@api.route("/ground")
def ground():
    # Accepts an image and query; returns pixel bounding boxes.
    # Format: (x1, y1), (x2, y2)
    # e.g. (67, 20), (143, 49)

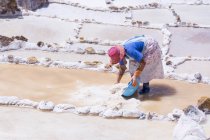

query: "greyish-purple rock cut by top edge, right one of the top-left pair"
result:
(17, 0), (48, 10)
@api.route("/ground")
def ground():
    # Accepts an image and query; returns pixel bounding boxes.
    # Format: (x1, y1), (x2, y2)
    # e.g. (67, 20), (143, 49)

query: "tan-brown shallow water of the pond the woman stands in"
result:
(0, 64), (210, 114)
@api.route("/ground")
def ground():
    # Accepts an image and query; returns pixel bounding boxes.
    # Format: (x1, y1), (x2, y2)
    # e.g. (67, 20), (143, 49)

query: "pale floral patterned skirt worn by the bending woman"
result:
(129, 37), (164, 83)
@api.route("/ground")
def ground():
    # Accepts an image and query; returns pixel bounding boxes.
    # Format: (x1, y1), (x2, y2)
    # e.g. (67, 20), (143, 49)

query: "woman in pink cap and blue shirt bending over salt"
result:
(107, 35), (164, 94)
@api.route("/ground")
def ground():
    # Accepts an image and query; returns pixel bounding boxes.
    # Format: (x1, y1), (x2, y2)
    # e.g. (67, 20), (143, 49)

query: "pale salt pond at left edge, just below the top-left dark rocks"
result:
(0, 16), (77, 43)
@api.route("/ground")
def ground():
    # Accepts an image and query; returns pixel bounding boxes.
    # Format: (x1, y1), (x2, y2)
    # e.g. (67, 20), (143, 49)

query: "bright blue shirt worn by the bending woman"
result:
(119, 36), (144, 65)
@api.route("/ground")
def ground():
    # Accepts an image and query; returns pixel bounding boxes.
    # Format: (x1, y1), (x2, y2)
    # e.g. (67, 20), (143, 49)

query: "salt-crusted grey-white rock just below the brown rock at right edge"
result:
(183, 105), (206, 123)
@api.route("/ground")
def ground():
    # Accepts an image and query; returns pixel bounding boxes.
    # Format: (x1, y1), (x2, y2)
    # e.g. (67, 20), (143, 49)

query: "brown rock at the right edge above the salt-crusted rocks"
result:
(197, 97), (210, 112)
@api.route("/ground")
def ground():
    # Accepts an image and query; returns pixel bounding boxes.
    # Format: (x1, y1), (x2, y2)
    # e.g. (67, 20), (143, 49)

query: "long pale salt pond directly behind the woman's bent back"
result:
(79, 23), (162, 44)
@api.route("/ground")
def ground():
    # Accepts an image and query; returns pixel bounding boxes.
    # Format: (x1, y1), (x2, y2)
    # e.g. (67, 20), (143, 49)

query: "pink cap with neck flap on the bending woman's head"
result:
(108, 46), (125, 64)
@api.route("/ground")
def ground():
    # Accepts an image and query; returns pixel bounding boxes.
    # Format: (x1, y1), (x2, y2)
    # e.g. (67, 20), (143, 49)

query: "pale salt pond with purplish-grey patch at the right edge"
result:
(169, 27), (210, 57)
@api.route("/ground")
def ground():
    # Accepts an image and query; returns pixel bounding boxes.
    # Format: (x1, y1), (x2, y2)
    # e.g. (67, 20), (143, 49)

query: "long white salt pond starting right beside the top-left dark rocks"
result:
(35, 3), (127, 24)
